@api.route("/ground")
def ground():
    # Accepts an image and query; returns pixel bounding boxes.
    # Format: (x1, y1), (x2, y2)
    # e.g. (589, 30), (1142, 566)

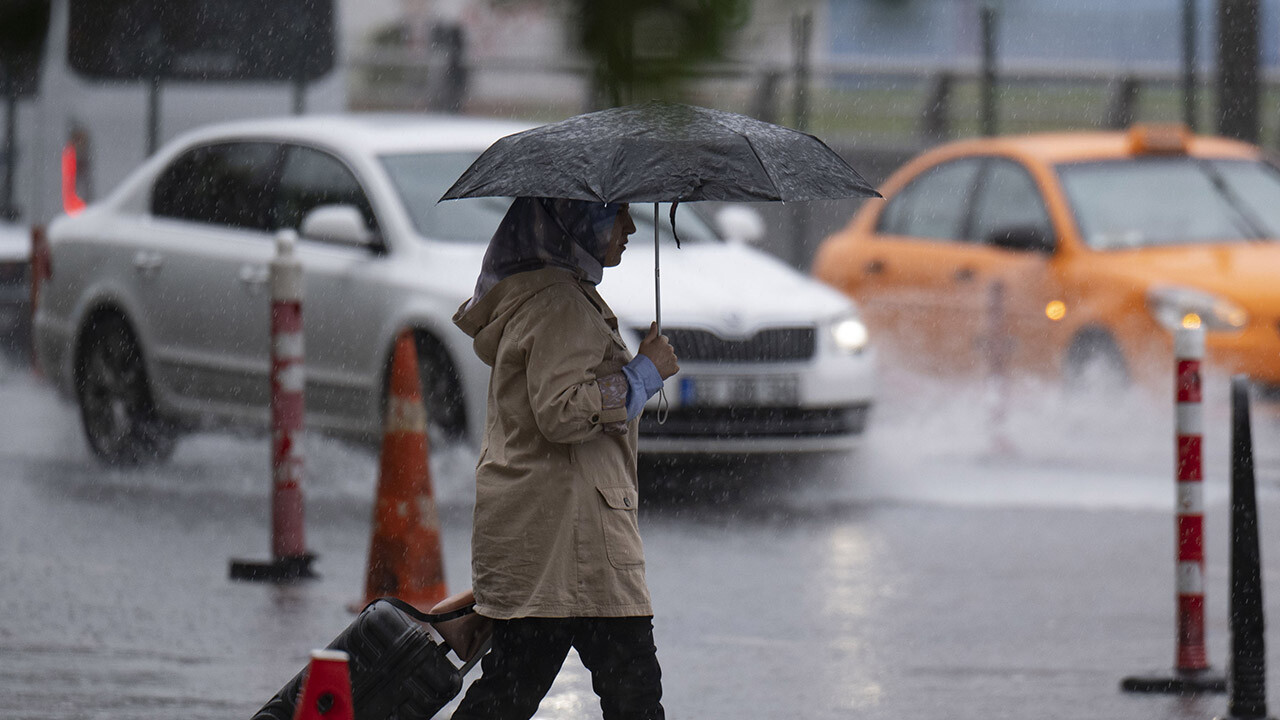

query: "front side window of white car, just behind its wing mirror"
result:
(271, 145), (378, 229)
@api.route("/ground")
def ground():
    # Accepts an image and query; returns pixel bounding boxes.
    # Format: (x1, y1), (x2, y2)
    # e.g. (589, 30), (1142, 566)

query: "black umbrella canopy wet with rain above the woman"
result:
(440, 101), (879, 202)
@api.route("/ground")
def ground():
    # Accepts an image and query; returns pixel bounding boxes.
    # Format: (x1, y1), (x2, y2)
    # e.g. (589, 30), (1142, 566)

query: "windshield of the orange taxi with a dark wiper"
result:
(1057, 156), (1280, 250)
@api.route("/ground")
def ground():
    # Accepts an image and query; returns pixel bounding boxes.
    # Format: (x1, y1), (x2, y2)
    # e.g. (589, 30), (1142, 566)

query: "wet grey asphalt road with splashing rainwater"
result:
(0, 358), (1280, 720)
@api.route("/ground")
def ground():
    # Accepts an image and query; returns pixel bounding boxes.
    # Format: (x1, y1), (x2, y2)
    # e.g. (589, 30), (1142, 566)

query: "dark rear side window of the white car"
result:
(151, 142), (278, 231)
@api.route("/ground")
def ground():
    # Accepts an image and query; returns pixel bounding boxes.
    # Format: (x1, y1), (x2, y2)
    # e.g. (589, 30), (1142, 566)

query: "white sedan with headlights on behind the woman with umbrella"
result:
(35, 115), (873, 464)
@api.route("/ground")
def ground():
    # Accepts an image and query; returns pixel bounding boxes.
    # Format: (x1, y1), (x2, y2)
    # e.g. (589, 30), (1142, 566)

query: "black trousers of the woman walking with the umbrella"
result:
(453, 618), (664, 720)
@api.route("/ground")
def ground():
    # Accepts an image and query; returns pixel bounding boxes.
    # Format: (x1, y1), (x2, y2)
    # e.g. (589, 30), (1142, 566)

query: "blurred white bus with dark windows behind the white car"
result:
(0, 0), (347, 225)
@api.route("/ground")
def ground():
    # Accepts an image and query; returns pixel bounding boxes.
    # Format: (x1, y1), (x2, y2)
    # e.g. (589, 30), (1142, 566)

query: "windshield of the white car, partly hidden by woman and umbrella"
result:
(381, 152), (718, 242)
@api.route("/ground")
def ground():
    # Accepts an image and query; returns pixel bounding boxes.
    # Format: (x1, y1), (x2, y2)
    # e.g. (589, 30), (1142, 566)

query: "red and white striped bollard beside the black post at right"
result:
(1120, 325), (1226, 693)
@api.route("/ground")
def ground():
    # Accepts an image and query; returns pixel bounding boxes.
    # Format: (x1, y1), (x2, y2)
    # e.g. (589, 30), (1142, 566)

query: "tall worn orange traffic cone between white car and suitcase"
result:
(357, 331), (448, 610)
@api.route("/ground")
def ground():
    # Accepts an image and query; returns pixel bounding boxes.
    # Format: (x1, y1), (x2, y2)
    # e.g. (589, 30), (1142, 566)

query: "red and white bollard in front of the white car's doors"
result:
(232, 231), (315, 582)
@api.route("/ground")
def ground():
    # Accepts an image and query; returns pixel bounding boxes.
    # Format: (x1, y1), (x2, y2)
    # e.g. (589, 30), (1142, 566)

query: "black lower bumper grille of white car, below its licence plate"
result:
(640, 405), (870, 438)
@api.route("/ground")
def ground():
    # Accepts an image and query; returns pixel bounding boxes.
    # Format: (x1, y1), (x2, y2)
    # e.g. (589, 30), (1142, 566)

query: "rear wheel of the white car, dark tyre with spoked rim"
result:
(76, 314), (177, 466)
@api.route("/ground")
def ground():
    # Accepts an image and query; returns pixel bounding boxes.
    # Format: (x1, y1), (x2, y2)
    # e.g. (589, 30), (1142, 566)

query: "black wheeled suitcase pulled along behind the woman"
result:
(253, 591), (488, 720)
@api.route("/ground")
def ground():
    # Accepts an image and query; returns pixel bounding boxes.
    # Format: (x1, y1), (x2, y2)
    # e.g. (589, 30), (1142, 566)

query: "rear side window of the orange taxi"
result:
(877, 158), (982, 240)
